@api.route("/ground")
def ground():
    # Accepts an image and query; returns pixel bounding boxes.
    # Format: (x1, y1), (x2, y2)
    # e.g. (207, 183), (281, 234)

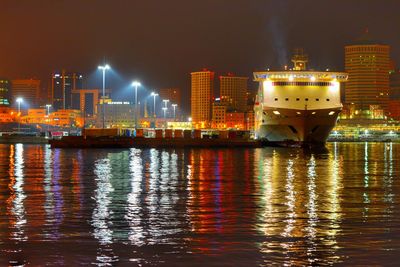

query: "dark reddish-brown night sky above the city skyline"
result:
(0, 0), (400, 111)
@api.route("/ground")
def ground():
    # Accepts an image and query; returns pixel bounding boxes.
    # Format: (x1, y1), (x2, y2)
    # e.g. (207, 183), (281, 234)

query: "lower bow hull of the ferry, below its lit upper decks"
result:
(257, 107), (341, 146)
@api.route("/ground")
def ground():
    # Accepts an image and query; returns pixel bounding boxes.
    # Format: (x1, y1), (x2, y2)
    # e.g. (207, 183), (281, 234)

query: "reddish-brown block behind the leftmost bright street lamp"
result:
(11, 79), (40, 108)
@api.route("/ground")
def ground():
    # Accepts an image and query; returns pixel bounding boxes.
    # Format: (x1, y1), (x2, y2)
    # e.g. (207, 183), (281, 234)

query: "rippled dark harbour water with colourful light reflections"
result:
(0, 143), (400, 266)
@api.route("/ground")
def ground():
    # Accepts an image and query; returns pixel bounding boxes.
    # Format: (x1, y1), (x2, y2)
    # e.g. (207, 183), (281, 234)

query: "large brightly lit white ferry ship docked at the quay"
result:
(254, 54), (348, 145)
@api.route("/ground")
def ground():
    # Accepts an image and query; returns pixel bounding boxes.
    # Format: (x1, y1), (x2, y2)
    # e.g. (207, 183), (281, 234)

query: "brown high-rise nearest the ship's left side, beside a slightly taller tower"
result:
(219, 73), (249, 112)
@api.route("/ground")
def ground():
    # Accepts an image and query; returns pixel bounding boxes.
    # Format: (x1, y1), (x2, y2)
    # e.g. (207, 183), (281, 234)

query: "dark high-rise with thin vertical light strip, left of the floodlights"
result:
(51, 70), (83, 110)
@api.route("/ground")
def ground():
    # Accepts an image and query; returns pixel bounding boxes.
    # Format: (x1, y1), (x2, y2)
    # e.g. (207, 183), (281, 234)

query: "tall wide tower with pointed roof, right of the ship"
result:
(345, 31), (390, 111)
